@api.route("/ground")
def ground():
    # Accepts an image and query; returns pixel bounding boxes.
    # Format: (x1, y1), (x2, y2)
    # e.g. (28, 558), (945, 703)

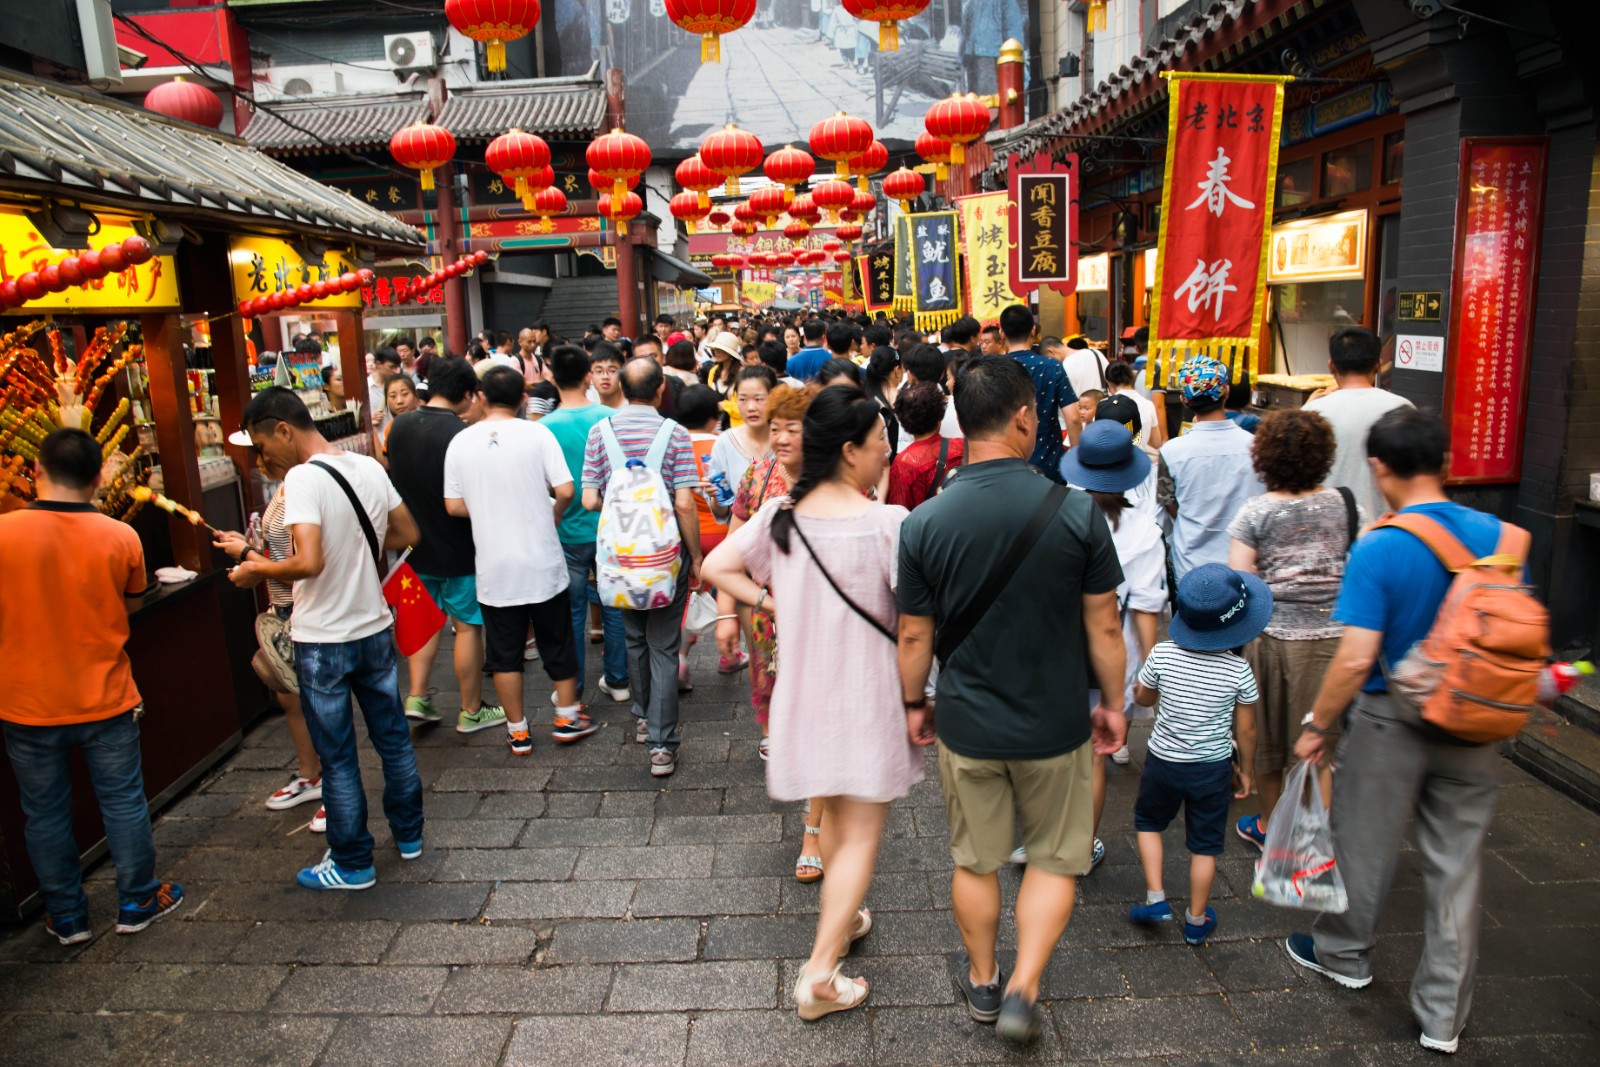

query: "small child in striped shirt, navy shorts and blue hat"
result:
(1128, 563), (1272, 945)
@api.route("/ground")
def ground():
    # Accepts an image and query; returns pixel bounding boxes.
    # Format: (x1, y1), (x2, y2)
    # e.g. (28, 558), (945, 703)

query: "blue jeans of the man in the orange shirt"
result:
(5, 710), (162, 920)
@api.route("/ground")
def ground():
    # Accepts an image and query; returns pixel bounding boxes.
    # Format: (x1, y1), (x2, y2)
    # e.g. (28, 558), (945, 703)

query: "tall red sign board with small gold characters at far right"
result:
(1445, 138), (1549, 483)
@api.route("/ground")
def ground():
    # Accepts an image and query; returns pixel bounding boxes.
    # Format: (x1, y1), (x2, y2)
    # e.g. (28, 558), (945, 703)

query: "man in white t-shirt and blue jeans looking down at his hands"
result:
(232, 387), (422, 889)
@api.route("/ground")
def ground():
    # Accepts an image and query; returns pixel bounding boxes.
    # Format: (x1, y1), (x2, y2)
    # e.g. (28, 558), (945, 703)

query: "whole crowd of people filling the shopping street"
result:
(0, 295), (1529, 1051)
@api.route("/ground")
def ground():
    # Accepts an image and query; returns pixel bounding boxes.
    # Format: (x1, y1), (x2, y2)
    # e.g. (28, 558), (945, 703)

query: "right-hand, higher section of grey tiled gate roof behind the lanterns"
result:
(437, 78), (605, 141)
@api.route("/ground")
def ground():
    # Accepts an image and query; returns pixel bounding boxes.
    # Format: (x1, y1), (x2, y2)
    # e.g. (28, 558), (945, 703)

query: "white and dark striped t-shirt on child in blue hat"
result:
(1139, 641), (1259, 763)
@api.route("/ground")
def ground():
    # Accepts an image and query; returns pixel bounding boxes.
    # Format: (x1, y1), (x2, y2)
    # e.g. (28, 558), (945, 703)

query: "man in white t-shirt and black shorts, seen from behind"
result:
(445, 366), (598, 755)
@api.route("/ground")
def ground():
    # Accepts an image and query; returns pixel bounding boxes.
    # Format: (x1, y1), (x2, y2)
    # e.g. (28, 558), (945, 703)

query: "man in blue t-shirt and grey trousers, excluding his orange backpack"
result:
(1288, 406), (1501, 1053)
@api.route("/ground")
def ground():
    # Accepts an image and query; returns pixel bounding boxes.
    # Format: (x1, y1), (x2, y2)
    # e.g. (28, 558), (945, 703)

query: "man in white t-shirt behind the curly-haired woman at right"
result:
(1306, 326), (1414, 517)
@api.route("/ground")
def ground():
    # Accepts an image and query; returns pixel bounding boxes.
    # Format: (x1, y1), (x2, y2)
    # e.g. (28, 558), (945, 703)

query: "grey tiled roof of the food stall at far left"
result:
(0, 72), (424, 250)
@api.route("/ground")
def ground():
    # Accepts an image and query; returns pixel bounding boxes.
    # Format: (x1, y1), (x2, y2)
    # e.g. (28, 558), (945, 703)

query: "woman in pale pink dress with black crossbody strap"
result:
(704, 386), (923, 1019)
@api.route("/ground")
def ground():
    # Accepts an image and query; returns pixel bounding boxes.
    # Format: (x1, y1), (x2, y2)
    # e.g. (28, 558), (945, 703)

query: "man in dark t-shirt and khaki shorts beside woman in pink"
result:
(898, 355), (1128, 1043)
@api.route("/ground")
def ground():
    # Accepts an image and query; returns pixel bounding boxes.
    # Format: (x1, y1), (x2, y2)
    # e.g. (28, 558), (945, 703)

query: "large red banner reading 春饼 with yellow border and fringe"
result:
(1150, 72), (1290, 384)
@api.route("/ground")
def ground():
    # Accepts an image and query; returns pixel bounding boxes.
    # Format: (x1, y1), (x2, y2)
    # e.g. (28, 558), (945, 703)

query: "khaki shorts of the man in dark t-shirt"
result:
(939, 742), (1094, 875)
